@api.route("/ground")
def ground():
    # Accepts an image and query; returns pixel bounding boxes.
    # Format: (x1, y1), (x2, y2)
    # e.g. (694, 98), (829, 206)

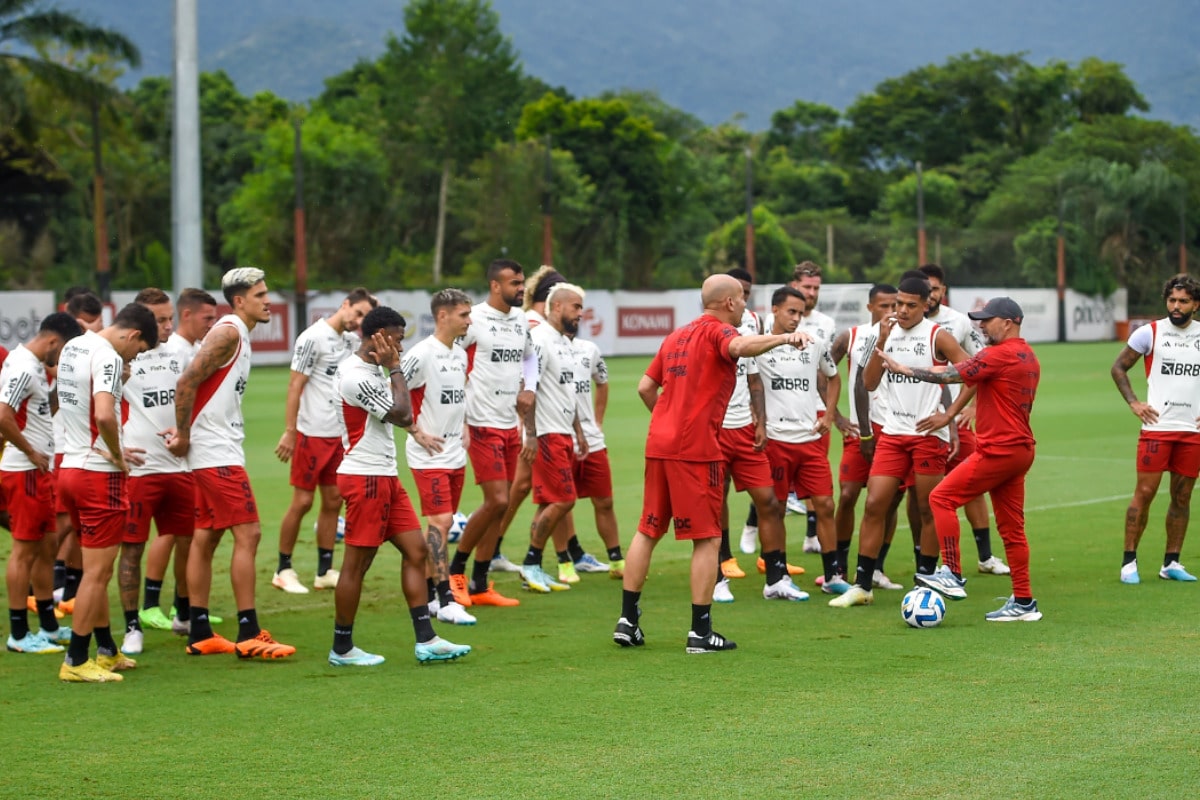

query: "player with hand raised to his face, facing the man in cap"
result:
(829, 277), (974, 608)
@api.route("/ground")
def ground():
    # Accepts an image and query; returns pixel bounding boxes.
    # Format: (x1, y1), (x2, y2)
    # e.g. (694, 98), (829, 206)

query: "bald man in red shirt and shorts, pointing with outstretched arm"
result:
(612, 275), (811, 654)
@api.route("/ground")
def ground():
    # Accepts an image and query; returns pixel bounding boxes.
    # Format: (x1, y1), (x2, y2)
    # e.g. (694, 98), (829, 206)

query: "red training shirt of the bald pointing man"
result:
(646, 314), (739, 462)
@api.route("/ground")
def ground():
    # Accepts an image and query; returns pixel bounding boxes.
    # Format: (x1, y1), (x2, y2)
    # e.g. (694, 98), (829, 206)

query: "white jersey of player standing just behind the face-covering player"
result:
(292, 319), (359, 439)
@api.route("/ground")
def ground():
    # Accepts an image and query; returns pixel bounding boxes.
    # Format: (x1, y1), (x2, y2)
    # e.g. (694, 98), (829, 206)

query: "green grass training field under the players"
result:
(0, 343), (1200, 799)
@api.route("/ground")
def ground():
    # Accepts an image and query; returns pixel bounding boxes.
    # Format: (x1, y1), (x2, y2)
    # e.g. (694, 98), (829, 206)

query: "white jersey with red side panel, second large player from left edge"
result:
(58, 331), (125, 473)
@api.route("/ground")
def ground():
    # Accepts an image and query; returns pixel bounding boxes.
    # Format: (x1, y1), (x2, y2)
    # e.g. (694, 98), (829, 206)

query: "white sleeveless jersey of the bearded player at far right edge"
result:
(1129, 317), (1200, 434)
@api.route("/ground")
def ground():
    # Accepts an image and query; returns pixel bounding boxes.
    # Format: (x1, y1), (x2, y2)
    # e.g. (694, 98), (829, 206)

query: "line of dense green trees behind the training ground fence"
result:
(0, 0), (1200, 311)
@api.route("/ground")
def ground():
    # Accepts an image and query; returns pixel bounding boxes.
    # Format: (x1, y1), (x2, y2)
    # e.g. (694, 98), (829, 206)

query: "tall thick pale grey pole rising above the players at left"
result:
(170, 0), (204, 293)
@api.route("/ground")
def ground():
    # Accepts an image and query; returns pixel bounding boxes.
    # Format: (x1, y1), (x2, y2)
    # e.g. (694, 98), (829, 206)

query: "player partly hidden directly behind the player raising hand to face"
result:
(833, 283), (904, 589)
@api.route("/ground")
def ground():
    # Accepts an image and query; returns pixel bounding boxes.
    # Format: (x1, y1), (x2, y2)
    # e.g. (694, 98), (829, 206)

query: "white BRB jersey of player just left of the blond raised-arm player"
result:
(121, 336), (192, 476)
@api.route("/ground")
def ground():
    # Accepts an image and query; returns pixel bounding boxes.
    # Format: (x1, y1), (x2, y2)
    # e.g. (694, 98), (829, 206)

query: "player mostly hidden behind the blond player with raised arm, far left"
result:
(137, 289), (222, 636)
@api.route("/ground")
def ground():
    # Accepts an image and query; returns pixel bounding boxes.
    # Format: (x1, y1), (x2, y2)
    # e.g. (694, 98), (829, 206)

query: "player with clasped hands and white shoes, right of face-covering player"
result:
(400, 289), (475, 625)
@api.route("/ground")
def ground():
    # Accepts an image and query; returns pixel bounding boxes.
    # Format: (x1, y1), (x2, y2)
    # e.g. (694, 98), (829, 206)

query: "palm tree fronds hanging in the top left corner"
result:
(0, 0), (142, 140)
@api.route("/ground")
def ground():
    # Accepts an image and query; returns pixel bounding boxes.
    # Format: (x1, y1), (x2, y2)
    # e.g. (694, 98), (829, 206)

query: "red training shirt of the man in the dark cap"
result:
(958, 338), (1042, 456)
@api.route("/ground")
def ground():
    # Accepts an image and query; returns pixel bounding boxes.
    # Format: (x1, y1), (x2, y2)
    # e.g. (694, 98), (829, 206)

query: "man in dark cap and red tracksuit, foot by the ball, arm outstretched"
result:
(886, 297), (1042, 622)
